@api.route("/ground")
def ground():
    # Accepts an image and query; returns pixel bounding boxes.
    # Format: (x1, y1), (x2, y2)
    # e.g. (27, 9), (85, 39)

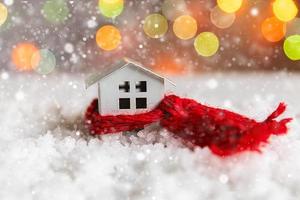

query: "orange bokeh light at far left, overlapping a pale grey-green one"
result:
(12, 42), (38, 71)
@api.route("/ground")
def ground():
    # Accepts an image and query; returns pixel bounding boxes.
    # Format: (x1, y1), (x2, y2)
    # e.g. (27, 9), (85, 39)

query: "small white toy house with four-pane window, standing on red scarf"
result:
(85, 58), (172, 115)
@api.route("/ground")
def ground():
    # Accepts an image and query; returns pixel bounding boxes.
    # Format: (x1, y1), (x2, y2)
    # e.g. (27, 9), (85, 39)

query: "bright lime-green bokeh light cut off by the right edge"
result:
(283, 35), (300, 60)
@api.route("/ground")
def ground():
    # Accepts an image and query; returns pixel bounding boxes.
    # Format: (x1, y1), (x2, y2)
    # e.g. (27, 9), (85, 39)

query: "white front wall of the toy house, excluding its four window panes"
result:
(99, 64), (164, 115)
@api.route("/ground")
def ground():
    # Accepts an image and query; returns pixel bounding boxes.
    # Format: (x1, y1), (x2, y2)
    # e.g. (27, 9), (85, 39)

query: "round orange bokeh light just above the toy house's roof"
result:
(96, 25), (122, 51)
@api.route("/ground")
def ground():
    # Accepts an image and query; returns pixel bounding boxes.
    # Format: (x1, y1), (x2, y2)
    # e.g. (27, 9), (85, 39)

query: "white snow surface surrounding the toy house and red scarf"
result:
(0, 73), (300, 200)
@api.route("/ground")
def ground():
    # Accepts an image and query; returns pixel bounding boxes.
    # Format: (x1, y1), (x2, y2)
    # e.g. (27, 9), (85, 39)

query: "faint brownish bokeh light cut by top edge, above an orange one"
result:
(161, 0), (187, 21)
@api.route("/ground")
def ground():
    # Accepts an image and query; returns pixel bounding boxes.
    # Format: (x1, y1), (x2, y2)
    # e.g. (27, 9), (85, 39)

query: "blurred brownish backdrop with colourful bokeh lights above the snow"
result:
(0, 0), (300, 74)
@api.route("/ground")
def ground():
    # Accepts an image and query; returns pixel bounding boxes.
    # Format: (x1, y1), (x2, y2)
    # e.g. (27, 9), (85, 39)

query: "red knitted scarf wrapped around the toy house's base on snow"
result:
(85, 95), (292, 156)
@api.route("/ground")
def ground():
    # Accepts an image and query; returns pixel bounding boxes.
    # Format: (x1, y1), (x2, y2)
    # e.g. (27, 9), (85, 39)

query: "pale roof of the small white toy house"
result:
(85, 58), (175, 88)
